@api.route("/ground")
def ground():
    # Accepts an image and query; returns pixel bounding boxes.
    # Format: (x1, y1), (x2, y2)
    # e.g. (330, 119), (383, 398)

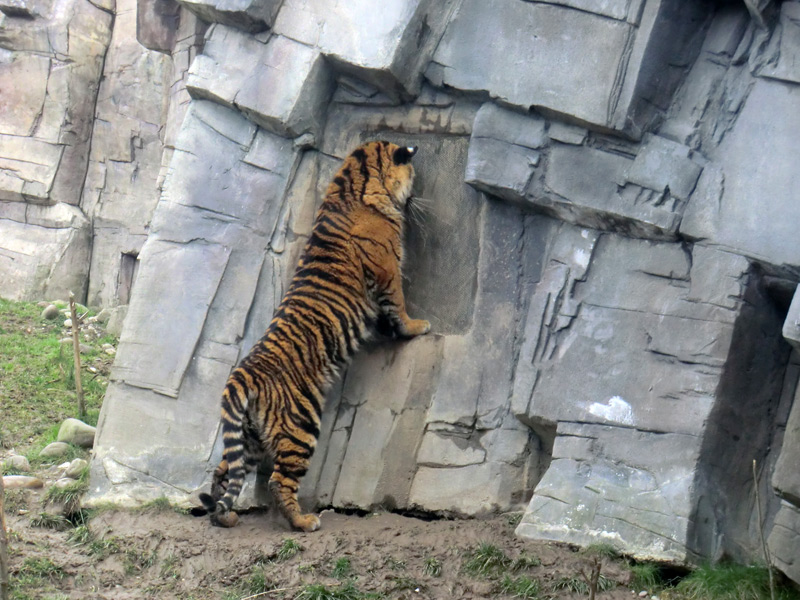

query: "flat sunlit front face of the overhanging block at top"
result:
(426, 0), (633, 125)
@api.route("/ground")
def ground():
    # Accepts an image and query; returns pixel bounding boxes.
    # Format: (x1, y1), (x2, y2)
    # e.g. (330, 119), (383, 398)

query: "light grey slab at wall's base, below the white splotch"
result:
(516, 423), (700, 562)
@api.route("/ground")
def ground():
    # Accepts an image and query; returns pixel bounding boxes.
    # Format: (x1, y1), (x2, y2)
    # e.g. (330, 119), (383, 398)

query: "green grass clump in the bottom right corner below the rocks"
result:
(672, 563), (800, 600)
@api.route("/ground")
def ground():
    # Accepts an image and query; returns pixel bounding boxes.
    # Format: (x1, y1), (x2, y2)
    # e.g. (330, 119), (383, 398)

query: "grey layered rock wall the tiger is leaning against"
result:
(0, 0), (800, 581)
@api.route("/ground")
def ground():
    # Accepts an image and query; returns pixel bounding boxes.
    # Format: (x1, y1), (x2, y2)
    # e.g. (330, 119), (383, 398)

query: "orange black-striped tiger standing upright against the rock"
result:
(195, 141), (430, 531)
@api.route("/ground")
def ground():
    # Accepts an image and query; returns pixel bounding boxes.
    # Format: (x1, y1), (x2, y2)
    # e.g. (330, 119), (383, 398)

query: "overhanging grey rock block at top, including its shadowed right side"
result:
(426, 0), (702, 137)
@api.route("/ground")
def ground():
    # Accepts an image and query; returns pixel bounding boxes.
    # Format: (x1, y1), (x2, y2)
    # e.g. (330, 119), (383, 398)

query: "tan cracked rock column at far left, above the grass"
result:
(0, 0), (114, 299)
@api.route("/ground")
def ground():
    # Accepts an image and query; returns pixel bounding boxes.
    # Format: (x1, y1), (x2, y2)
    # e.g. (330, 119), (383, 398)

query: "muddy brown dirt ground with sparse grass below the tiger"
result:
(6, 482), (638, 600)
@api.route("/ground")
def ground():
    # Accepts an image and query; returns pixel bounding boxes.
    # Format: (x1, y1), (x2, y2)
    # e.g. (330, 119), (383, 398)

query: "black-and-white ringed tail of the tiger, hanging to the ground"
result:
(200, 378), (248, 527)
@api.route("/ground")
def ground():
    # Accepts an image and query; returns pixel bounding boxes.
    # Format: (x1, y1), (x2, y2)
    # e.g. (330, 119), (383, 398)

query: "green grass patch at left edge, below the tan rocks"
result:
(0, 298), (113, 452)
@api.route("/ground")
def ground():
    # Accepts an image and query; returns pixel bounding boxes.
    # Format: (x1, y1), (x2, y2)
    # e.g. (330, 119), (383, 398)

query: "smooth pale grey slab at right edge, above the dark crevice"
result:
(680, 79), (800, 267)
